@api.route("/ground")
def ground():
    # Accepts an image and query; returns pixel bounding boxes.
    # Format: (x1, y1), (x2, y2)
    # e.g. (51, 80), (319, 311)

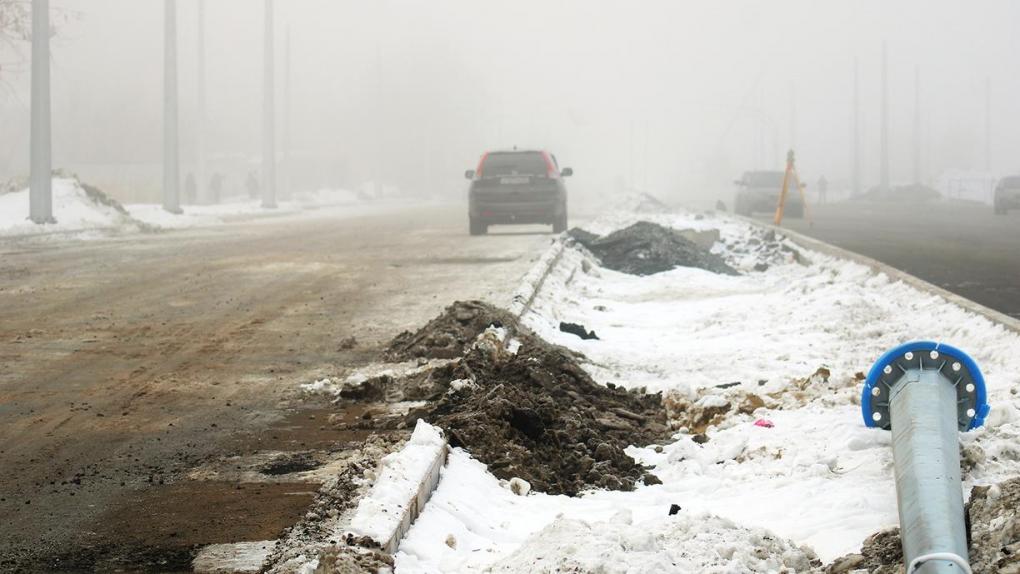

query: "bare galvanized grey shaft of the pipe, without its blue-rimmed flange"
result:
(889, 369), (969, 574)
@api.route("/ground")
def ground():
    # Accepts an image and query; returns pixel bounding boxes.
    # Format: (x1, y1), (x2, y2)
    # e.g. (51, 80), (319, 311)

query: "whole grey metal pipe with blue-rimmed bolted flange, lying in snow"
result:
(861, 342), (988, 574)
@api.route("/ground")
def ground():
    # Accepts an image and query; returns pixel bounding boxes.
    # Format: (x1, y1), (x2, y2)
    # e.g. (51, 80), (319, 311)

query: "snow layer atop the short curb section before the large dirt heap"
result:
(351, 420), (447, 546)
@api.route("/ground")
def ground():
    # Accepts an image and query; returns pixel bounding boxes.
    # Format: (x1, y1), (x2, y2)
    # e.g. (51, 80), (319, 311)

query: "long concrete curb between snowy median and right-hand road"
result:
(754, 215), (1020, 334)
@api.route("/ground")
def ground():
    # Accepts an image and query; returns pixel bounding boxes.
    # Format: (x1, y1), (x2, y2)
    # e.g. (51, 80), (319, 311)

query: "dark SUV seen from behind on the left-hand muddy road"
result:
(464, 150), (573, 236)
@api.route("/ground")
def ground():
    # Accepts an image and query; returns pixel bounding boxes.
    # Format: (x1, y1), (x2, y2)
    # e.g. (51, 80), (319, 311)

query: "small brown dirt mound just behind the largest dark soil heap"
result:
(387, 301), (516, 361)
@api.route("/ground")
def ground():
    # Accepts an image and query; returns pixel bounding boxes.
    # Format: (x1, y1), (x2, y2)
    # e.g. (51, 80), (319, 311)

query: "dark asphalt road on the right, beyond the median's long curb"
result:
(771, 202), (1020, 317)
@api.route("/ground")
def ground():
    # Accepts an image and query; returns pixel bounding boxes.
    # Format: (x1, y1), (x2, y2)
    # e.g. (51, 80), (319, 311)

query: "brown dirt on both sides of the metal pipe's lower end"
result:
(825, 478), (1020, 574)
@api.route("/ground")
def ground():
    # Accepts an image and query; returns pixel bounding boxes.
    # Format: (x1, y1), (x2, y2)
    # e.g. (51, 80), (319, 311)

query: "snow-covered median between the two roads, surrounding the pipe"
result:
(397, 209), (1020, 573)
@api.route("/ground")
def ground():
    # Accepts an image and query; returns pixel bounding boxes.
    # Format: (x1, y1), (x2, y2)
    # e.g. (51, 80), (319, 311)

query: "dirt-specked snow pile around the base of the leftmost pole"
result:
(0, 177), (140, 237)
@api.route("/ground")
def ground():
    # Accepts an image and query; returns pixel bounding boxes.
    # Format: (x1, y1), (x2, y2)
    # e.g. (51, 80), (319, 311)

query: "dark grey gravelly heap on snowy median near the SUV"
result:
(568, 221), (740, 275)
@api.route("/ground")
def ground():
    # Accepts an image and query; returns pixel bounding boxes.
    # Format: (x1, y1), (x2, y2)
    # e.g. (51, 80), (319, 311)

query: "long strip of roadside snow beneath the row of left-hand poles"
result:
(0, 177), (391, 239)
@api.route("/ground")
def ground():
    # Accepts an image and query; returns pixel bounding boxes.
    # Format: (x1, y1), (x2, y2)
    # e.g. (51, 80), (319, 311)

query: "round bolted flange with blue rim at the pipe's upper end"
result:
(861, 341), (991, 431)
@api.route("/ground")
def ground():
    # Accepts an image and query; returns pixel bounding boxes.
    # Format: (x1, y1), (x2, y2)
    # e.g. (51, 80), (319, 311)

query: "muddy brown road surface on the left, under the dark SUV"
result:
(0, 205), (550, 572)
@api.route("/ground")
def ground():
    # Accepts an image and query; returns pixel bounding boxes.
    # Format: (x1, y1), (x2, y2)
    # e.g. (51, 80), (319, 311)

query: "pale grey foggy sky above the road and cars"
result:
(0, 0), (1020, 201)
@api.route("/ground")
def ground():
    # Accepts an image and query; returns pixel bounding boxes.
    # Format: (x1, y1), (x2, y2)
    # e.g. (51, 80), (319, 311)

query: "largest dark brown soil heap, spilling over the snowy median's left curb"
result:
(392, 303), (669, 495)
